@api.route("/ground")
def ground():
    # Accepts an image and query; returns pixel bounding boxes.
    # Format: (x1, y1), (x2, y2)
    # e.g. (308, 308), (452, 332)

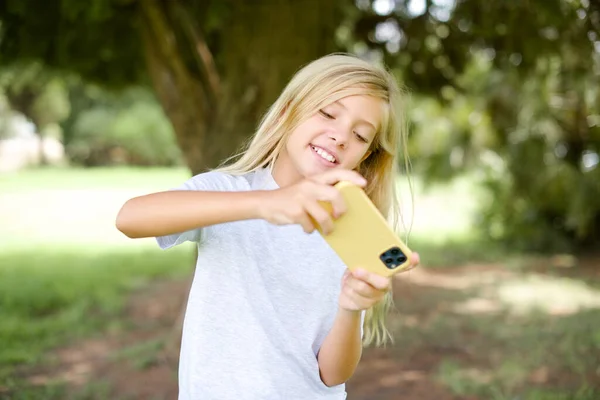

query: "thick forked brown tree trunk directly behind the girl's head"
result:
(142, 0), (340, 174)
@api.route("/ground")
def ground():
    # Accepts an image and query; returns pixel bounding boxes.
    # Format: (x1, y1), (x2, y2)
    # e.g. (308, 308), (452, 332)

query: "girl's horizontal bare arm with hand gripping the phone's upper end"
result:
(116, 169), (366, 238)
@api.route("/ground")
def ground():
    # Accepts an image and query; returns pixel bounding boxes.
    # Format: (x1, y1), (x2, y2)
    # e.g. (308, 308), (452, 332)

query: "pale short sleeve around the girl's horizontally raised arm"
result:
(156, 171), (235, 250)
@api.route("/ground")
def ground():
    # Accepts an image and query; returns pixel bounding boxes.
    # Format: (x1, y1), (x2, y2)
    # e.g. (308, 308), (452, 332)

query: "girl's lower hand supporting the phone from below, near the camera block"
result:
(339, 253), (419, 311)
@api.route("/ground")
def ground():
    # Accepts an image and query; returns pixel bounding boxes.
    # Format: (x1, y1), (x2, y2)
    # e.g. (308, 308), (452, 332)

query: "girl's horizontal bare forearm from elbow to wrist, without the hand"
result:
(116, 190), (264, 238)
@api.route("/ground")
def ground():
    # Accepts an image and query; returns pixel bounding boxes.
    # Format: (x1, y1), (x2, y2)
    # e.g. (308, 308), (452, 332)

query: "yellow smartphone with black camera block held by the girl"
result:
(316, 181), (412, 277)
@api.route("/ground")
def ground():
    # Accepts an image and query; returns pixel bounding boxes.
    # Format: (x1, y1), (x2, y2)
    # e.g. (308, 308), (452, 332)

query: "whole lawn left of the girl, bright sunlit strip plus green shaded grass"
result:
(0, 168), (193, 398)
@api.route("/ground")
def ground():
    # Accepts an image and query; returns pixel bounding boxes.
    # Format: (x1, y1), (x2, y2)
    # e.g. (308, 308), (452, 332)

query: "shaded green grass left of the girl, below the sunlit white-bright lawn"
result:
(0, 248), (192, 371)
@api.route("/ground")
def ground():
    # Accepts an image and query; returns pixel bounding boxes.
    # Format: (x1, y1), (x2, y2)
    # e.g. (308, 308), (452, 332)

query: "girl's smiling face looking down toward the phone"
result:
(273, 95), (383, 186)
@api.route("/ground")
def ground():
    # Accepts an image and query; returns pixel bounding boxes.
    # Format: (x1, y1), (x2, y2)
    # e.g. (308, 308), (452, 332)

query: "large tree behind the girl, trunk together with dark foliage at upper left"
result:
(0, 0), (343, 173)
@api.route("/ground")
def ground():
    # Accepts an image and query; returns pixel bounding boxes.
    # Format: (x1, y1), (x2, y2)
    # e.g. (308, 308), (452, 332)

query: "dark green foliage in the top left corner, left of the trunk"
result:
(0, 0), (145, 86)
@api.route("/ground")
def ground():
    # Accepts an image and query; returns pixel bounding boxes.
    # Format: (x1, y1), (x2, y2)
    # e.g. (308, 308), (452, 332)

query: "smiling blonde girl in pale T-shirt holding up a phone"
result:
(117, 54), (418, 400)
